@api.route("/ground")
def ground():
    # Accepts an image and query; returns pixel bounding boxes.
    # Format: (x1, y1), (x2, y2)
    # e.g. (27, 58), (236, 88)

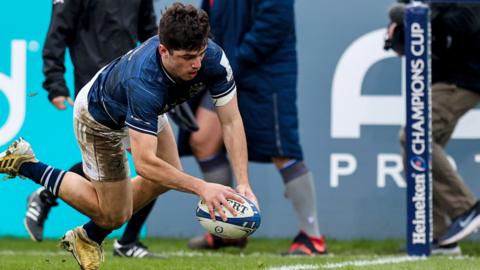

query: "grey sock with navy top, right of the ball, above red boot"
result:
(280, 160), (320, 237)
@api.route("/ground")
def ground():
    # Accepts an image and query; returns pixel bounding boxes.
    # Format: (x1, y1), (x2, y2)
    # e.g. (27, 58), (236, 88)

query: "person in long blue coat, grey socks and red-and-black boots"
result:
(179, 0), (326, 255)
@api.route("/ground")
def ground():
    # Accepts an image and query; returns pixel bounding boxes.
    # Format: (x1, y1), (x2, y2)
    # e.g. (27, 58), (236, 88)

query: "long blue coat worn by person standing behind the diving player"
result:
(179, 0), (303, 162)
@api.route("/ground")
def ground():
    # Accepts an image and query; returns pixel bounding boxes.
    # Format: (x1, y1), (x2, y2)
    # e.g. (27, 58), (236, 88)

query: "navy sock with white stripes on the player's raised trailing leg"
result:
(19, 162), (65, 197)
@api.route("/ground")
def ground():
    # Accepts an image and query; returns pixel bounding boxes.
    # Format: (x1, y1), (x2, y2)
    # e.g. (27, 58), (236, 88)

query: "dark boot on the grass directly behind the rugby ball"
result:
(188, 233), (248, 250)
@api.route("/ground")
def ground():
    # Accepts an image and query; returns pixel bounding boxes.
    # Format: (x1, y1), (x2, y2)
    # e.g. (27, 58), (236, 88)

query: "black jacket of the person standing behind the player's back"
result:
(43, 0), (157, 100)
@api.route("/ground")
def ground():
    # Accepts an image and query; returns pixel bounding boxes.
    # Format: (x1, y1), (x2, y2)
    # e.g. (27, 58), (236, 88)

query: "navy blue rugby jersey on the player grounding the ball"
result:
(88, 36), (236, 135)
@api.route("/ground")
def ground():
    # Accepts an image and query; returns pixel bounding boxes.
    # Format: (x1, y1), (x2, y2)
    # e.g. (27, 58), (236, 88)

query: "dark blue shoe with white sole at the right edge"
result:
(438, 201), (480, 246)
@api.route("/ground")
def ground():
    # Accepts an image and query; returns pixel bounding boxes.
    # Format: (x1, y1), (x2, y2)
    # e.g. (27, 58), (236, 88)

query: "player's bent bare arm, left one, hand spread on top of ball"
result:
(129, 129), (243, 220)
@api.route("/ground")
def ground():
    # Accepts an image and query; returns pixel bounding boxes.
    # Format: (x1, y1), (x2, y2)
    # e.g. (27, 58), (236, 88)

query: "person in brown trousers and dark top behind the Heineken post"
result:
(385, 0), (480, 255)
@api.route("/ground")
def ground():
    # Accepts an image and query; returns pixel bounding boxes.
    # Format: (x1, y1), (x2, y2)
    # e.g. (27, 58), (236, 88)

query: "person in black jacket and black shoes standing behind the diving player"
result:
(24, 0), (157, 258)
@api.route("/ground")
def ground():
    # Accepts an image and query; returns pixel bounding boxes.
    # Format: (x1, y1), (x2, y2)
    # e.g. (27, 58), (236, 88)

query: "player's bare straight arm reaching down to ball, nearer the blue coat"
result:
(217, 96), (258, 205)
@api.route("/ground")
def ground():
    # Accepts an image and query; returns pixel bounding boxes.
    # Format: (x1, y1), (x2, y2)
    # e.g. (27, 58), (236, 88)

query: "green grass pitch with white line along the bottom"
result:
(0, 238), (480, 270)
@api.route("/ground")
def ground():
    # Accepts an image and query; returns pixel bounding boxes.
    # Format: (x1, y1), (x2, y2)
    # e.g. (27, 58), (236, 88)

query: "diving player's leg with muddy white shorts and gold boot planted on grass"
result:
(60, 118), (132, 269)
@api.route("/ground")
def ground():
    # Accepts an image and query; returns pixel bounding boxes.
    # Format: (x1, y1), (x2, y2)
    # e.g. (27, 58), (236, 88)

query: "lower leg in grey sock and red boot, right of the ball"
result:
(272, 157), (326, 255)
